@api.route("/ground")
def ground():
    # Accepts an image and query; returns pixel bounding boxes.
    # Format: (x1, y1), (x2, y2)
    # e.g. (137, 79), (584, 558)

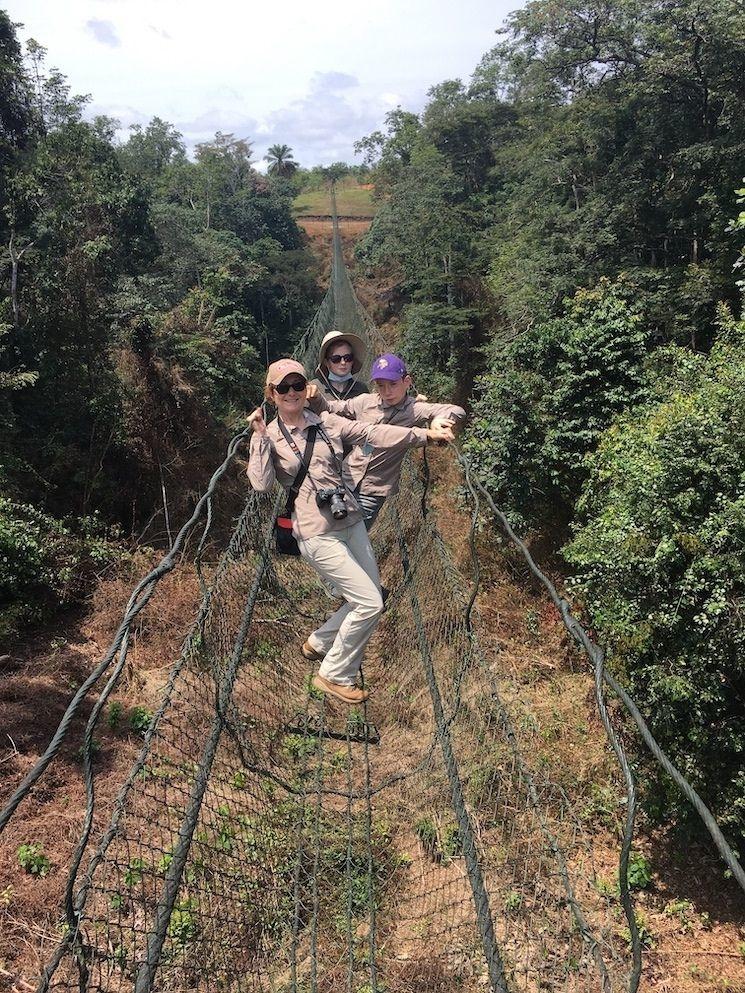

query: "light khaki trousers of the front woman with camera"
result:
(298, 521), (383, 686)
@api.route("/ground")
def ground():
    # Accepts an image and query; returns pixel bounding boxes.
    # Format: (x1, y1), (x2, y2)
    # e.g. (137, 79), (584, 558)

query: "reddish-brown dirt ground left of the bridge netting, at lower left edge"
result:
(0, 553), (198, 991)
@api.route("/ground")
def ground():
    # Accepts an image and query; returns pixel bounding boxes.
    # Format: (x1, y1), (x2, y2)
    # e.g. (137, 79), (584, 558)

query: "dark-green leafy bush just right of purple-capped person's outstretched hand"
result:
(465, 280), (648, 522)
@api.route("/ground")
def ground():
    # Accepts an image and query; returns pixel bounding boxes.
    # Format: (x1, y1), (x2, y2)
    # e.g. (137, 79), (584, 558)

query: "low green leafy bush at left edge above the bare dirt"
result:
(0, 496), (124, 638)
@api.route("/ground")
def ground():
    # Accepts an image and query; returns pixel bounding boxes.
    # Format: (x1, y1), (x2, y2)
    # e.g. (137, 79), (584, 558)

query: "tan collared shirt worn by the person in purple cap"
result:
(310, 393), (466, 496)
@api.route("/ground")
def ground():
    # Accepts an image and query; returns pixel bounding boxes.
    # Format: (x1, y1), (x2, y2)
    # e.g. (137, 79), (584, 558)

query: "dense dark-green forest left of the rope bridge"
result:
(0, 12), (318, 636)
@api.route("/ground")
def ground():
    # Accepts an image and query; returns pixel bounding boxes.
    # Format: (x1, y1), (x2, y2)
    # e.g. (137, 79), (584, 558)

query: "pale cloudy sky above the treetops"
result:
(0, 0), (523, 166)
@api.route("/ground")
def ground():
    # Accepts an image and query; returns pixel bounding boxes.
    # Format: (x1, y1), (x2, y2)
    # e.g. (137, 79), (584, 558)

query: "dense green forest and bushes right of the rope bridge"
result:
(358, 0), (745, 836)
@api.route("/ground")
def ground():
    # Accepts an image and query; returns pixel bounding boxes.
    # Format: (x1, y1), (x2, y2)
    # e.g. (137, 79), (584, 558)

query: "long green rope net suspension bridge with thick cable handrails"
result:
(0, 198), (742, 993)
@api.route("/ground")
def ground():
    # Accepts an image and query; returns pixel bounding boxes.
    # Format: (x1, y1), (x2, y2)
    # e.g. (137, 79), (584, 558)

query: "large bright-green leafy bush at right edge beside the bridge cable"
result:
(564, 330), (745, 838)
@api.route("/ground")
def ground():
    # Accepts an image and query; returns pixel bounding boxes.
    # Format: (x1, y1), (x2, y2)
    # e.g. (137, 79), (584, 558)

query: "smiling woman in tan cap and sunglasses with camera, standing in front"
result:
(248, 359), (453, 704)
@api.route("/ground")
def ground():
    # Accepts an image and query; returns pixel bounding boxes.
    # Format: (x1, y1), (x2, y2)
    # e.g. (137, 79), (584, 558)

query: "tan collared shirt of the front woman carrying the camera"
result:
(248, 410), (427, 538)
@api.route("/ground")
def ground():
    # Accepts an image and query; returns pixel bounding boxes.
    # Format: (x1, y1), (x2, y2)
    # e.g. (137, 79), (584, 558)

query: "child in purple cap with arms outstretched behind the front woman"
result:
(314, 352), (466, 531)
